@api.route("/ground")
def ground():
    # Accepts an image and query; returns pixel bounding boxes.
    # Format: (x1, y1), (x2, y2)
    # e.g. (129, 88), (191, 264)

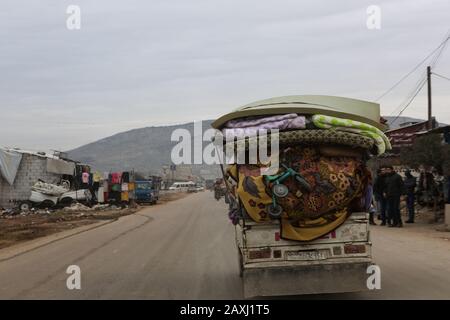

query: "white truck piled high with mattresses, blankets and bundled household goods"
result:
(212, 96), (391, 298)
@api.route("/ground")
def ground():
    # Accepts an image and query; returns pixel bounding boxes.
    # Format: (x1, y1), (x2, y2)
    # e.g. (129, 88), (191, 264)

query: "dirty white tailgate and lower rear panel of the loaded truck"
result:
(236, 212), (372, 297)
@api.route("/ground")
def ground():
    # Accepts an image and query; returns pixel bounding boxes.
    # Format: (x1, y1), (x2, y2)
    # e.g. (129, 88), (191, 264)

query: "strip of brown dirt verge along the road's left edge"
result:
(0, 193), (188, 249)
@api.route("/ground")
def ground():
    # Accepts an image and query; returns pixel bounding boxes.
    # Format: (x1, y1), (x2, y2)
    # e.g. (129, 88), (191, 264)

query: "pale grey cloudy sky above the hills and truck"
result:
(0, 0), (450, 150)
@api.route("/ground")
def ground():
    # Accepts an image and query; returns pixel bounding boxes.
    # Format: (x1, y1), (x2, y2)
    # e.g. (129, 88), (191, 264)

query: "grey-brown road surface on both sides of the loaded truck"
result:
(0, 191), (450, 299)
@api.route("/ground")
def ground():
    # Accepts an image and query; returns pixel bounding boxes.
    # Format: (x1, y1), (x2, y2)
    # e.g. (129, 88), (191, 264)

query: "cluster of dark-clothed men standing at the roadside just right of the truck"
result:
(370, 165), (417, 228)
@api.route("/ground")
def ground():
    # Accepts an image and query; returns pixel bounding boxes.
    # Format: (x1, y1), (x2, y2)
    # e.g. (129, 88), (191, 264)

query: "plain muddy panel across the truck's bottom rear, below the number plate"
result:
(243, 259), (373, 298)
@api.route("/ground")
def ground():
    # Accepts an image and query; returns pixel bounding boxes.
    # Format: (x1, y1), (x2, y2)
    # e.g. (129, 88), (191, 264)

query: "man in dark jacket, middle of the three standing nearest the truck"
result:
(384, 166), (404, 227)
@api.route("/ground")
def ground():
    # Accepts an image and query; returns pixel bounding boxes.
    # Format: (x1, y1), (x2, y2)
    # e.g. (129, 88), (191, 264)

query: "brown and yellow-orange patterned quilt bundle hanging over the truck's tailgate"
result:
(228, 146), (368, 241)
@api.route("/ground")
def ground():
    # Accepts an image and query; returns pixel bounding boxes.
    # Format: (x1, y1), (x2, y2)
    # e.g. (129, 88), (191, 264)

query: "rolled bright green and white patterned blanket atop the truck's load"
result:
(312, 114), (392, 155)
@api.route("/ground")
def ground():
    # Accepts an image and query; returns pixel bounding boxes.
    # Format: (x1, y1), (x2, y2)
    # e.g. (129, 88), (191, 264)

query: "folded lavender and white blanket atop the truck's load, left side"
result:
(222, 113), (306, 139)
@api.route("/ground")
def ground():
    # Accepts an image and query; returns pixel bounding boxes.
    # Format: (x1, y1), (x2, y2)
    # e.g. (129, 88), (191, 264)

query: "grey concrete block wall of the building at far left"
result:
(0, 154), (61, 208)
